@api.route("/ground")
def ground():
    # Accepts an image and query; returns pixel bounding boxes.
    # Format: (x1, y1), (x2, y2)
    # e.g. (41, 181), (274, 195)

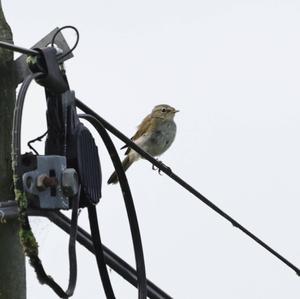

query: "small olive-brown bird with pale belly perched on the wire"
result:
(107, 104), (179, 184)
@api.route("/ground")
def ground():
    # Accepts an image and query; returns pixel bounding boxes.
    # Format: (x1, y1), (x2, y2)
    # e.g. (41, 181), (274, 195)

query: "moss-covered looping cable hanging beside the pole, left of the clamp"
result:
(12, 73), (80, 298)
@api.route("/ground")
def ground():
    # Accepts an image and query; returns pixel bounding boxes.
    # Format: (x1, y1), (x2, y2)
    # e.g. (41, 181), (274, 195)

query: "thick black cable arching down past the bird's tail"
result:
(80, 115), (147, 299)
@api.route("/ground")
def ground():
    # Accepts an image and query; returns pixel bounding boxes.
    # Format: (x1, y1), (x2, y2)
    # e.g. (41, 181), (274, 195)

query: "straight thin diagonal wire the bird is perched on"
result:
(76, 99), (300, 276)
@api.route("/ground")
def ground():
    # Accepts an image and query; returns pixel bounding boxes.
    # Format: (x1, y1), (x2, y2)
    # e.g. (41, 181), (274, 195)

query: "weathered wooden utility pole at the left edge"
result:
(0, 0), (26, 299)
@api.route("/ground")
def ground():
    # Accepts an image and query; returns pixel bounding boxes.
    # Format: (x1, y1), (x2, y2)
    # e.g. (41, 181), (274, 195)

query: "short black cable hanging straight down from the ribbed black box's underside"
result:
(88, 206), (116, 299)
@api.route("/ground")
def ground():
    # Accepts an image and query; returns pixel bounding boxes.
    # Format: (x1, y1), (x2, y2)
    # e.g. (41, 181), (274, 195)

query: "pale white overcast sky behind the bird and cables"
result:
(2, 0), (300, 299)
